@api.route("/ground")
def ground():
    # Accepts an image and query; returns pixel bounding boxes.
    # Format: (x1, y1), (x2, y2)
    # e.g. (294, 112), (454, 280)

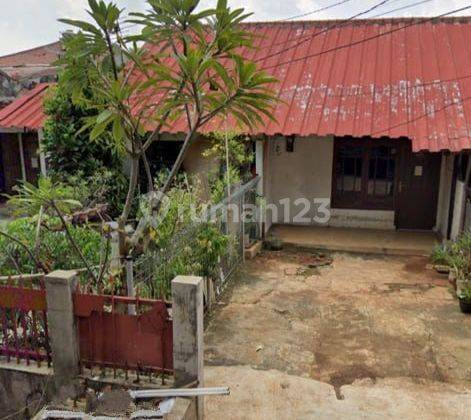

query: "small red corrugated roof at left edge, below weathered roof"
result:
(0, 83), (50, 131)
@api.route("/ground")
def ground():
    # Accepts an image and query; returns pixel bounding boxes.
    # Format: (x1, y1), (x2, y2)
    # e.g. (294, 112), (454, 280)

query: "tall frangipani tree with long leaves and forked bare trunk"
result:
(62, 0), (276, 253)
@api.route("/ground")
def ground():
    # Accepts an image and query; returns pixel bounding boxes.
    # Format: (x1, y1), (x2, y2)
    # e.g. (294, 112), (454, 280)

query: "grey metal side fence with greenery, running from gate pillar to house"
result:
(132, 177), (261, 306)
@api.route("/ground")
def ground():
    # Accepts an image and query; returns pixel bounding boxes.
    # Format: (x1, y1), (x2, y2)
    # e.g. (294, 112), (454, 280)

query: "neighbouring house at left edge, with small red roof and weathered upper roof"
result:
(0, 42), (62, 193)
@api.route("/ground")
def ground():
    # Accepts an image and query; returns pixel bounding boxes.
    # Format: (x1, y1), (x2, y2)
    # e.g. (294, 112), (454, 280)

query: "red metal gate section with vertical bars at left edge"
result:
(0, 276), (51, 366)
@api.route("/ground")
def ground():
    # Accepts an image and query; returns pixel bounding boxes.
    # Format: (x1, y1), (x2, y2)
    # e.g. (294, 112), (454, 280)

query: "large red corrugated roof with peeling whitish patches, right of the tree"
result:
(136, 17), (471, 151)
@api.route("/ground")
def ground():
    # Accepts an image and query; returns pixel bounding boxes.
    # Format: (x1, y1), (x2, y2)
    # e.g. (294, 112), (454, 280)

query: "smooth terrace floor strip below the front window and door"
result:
(269, 225), (439, 256)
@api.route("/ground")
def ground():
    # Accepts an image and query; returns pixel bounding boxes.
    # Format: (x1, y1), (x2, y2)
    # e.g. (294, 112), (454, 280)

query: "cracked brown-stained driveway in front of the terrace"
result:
(205, 250), (471, 387)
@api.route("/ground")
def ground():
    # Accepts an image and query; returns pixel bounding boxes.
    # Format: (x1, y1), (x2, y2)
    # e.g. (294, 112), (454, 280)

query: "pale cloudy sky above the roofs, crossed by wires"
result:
(0, 0), (471, 56)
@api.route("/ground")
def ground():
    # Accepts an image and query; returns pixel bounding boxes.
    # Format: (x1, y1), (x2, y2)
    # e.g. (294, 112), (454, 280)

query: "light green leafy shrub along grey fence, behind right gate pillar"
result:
(135, 179), (231, 298)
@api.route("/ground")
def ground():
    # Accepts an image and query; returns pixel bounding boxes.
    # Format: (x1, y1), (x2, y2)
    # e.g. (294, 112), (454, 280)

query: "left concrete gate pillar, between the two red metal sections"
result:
(46, 271), (79, 397)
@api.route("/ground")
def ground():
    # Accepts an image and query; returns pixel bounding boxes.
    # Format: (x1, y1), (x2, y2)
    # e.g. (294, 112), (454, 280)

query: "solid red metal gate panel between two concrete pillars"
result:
(74, 292), (173, 375)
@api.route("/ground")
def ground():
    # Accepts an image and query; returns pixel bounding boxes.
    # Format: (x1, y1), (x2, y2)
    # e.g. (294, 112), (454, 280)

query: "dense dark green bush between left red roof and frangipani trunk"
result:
(43, 85), (127, 217)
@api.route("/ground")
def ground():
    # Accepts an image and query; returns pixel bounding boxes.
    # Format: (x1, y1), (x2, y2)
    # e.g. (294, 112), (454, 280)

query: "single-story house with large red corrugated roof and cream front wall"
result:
(0, 17), (471, 243)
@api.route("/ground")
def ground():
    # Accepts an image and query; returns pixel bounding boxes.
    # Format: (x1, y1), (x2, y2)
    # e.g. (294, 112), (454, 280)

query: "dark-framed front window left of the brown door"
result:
(332, 138), (397, 209)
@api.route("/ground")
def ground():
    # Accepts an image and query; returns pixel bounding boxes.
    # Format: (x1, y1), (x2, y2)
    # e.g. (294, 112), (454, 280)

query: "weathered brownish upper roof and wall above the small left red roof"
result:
(0, 41), (62, 90)
